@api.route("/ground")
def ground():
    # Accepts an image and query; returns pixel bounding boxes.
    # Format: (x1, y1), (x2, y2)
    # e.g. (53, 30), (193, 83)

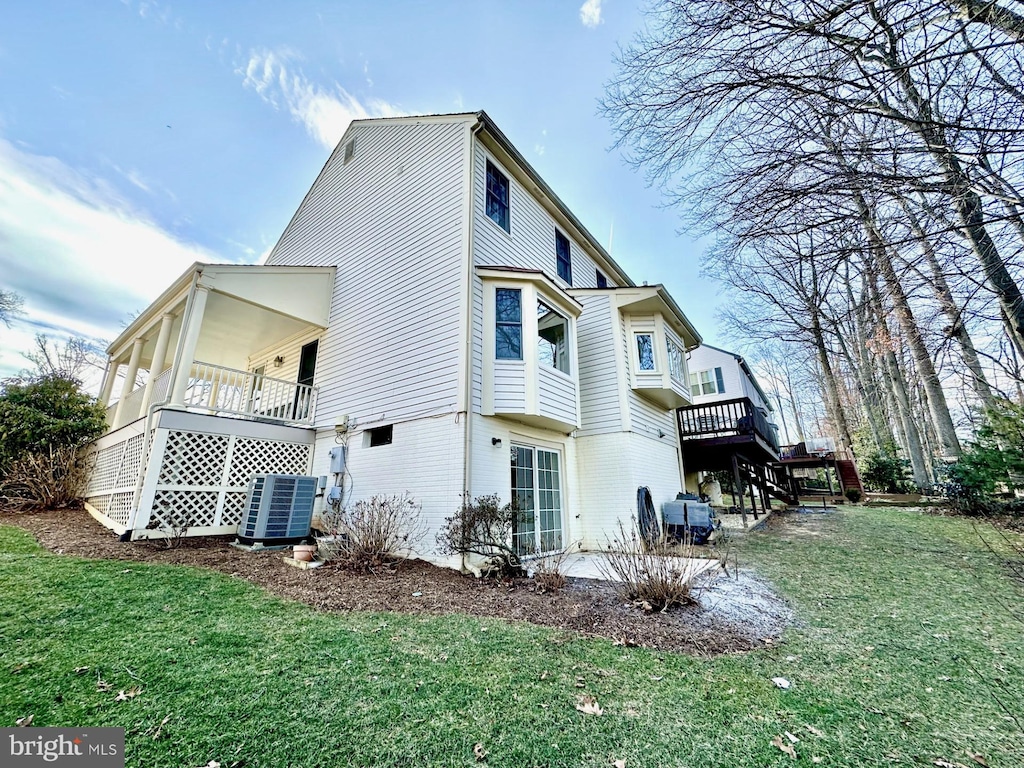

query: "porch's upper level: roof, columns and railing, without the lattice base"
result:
(99, 263), (335, 431)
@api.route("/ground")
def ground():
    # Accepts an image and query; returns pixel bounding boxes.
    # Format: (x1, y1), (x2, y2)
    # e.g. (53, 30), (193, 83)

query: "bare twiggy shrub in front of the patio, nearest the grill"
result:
(598, 519), (696, 611)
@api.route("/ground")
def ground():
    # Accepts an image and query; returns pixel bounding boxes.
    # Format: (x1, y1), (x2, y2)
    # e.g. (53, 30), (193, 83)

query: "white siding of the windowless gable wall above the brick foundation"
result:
(267, 121), (465, 427)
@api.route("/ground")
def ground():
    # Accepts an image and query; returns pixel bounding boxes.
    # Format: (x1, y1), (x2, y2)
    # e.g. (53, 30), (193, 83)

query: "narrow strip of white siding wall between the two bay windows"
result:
(577, 294), (629, 436)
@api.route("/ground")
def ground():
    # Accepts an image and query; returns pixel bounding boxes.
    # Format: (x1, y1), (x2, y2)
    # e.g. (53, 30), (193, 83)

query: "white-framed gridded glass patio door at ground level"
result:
(512, 445), (562, 556)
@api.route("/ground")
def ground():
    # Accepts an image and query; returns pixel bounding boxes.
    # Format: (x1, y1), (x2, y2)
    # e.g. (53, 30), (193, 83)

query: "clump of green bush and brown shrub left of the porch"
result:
(0, 375), (106, 508)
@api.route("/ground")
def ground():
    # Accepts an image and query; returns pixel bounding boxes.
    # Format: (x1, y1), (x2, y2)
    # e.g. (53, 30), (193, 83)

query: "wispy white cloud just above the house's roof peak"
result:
(237, 49), (401, 150)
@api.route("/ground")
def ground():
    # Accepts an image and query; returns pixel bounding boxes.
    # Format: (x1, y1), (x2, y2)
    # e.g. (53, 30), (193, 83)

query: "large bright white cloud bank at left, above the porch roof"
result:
(0, 139), (216, 376)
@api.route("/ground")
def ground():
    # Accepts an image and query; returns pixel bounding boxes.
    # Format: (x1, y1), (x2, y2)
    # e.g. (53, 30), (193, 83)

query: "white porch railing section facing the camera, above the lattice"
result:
(182, 360), (316, 424)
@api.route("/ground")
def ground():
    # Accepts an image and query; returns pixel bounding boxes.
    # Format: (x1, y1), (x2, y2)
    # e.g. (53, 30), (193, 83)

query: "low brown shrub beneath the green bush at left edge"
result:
(0, 445), (87, 510)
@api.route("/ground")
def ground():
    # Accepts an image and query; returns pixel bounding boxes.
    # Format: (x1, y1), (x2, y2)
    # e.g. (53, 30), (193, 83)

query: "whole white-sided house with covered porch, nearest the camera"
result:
(88, 112), (700, 564)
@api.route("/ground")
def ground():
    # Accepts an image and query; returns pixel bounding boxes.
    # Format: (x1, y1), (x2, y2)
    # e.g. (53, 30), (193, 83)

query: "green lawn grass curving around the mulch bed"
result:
(0, 508), (1024, 768)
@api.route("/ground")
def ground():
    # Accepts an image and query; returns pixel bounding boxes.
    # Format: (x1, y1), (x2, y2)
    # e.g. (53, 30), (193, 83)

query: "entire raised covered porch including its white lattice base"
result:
(86, 263), (335, 539)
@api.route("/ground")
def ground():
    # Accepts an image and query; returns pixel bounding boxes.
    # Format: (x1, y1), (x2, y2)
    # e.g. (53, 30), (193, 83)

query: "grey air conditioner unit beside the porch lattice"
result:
(239, 475), (316, 545)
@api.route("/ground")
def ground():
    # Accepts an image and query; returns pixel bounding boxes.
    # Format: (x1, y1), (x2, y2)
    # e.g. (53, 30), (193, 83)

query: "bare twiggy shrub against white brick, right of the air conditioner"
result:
(316, 494), (426, 571)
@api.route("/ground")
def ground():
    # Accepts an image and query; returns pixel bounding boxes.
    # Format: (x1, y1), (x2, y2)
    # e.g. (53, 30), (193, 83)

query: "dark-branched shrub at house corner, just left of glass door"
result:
(437, 495), (525, 578)
